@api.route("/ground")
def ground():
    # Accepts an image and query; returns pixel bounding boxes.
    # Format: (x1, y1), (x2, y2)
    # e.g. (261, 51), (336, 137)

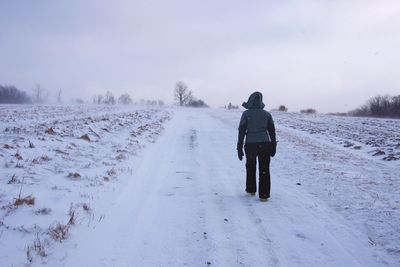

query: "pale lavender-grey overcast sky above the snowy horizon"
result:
(0, 0), (400, 112)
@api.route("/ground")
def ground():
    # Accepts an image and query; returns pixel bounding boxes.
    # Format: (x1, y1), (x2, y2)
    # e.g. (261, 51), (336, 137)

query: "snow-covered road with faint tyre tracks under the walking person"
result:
(47, 109), (398, 266)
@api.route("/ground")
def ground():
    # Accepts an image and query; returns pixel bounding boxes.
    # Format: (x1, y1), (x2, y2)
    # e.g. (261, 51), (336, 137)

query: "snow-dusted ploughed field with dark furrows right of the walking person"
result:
(274, 112), (400, 161)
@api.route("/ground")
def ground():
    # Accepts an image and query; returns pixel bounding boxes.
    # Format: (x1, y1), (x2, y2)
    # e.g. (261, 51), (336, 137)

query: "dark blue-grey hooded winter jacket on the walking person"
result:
(238, 92), (276, 147)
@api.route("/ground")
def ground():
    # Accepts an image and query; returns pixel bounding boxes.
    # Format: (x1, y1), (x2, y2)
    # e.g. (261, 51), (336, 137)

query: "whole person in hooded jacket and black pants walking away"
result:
(237, 92), (276, 201)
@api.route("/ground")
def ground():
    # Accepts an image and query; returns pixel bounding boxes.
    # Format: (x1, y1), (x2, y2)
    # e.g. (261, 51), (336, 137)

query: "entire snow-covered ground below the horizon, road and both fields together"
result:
(0, 106), (400, 266)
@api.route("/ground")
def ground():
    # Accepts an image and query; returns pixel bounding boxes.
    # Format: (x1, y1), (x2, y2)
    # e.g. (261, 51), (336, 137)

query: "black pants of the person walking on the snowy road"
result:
(244, 142), (271, 198)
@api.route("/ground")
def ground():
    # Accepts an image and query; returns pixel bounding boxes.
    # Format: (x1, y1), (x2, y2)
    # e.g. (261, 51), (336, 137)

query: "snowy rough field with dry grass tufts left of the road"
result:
(0, 105), (170, 266)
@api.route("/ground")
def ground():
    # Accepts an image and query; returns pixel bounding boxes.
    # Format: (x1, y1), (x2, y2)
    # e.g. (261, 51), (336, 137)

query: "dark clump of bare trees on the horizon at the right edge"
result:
(348, 95), (400, 118)
